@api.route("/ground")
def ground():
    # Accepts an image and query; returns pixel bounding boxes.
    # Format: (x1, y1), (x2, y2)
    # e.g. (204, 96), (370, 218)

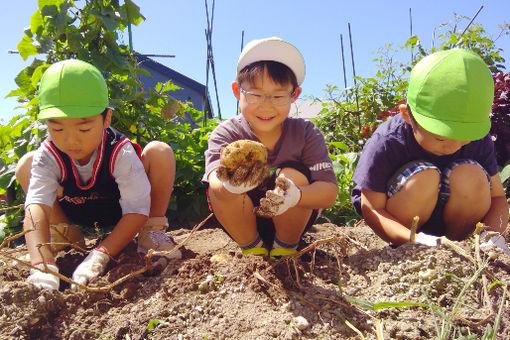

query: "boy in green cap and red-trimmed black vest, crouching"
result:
(16, 60), (180, 289)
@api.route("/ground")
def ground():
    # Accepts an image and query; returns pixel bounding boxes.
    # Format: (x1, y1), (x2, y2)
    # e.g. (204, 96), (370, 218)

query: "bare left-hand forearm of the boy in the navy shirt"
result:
(361, 189), (411, 245)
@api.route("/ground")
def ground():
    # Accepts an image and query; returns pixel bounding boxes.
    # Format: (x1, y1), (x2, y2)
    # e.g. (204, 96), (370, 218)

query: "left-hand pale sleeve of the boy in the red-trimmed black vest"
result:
(25, 146), (60, 208)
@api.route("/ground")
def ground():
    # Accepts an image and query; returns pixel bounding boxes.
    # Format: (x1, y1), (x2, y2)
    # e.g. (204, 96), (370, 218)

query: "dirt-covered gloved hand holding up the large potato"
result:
(216, 161), (269, 194)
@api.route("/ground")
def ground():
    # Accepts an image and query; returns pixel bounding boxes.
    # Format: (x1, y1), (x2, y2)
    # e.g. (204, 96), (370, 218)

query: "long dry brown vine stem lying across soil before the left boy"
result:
(0, 214), (213, 293)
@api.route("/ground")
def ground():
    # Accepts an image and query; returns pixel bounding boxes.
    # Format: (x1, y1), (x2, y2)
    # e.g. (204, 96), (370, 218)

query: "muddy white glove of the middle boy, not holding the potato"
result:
(255, 177), (301, 217)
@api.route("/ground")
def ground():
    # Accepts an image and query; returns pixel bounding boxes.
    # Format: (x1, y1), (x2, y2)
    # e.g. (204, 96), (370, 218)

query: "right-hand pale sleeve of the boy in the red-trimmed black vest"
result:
(112, 143), (151, 216)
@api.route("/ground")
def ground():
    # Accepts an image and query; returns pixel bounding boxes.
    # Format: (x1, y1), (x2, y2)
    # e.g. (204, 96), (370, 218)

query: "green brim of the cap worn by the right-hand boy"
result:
(411, 107), (491, 141)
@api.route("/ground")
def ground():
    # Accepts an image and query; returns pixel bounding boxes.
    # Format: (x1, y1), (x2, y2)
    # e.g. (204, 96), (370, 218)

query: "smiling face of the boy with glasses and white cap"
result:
(232, 71), (301, 138)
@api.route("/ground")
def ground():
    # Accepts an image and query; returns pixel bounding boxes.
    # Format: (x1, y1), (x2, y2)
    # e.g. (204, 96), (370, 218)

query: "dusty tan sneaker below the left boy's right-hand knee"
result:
(138, 217), (182, 259)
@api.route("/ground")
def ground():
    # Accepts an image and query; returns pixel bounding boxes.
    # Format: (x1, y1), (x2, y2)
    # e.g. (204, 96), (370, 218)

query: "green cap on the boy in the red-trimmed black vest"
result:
(39, 59), (108, 120)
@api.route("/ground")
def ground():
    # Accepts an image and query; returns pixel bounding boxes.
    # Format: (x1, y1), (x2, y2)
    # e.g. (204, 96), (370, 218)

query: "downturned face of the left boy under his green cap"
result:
(46, 109), (112, 165)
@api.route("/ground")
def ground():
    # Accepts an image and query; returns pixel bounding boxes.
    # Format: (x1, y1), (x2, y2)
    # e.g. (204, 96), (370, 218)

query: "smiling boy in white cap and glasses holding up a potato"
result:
(203, 37), (337, 258)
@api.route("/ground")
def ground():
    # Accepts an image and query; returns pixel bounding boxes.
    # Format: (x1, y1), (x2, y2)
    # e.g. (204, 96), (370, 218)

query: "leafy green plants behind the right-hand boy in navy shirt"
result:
(314, 15), (510, 221)
